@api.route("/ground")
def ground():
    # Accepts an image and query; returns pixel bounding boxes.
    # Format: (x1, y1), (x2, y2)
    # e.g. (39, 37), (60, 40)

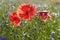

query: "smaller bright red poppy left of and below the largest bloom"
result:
(10, 12), (21, 26)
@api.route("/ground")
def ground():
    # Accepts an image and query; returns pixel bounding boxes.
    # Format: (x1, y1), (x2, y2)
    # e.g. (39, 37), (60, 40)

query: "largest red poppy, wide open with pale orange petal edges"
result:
(17, 4), (36, 21)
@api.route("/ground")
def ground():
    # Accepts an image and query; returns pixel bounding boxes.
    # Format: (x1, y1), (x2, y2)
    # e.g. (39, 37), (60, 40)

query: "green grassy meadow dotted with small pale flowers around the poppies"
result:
(0, 0), (60, 40)
